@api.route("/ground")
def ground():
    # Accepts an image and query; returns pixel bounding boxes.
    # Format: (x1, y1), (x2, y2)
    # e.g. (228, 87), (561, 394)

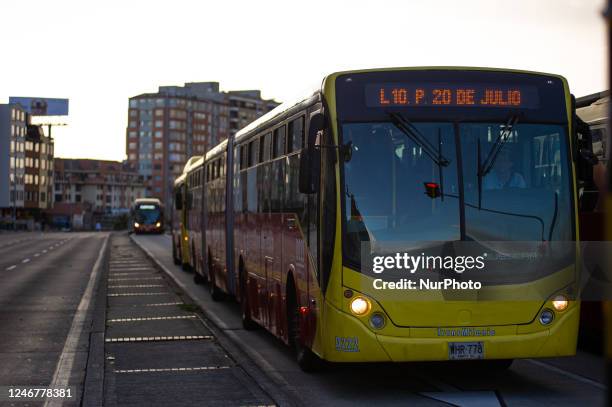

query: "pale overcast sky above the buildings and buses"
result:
(0, 0), (608, 160)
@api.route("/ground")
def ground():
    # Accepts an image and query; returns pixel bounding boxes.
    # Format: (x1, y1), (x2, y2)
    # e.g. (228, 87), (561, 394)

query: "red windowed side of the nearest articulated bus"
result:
(197, 95), (321, 346)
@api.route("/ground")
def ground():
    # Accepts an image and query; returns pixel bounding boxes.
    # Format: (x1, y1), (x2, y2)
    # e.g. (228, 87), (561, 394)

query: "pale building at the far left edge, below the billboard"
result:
(0, 104), (27, 223)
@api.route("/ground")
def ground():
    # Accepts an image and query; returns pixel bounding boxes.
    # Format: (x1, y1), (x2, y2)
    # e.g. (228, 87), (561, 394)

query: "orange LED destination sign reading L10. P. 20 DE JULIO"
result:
(365, 83), (539, 109)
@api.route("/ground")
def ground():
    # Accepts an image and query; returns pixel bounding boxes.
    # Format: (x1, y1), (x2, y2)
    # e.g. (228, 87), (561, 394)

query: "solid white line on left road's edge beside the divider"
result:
(44, 235), (110, 407)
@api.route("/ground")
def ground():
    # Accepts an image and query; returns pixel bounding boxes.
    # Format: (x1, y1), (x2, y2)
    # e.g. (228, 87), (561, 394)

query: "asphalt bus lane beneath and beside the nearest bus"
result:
(133, 235), (606, 406)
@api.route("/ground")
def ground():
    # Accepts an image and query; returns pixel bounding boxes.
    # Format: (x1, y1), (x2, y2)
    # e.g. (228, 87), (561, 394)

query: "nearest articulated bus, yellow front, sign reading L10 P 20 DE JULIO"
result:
(185, 68), (586, 370)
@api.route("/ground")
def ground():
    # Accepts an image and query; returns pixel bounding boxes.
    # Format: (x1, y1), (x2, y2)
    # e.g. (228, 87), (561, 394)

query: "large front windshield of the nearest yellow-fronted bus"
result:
(342, 120), (573, 264)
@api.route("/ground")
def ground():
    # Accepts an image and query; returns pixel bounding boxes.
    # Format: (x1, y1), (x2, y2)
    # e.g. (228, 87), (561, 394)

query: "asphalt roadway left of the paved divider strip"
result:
(0, 233), (107, 405)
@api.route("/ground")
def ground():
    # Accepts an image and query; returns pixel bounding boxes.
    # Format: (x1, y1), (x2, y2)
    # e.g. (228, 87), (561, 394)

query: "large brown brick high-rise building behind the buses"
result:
(126, 82), (280, 207)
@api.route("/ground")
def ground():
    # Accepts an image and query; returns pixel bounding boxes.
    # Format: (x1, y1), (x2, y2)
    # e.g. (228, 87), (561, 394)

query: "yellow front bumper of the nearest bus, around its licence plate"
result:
(317, 304), (580, 362)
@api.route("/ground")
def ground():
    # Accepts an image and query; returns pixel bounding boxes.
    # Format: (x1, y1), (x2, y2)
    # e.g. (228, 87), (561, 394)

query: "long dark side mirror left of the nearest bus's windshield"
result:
(299, 111), (325, 194)
